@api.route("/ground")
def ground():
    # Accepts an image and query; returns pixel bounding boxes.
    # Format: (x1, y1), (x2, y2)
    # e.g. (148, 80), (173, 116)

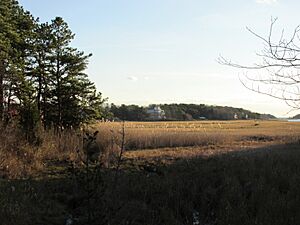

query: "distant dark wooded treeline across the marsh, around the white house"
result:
(109, 104), (275, 121)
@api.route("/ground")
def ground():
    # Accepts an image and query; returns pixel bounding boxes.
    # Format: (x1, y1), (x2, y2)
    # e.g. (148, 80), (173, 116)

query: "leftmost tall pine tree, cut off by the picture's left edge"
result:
(0, 0), (36, 123)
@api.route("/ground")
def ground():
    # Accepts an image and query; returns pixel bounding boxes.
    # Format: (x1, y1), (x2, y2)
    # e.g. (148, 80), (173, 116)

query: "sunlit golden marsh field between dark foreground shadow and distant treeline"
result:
(92, 120), (300, 163)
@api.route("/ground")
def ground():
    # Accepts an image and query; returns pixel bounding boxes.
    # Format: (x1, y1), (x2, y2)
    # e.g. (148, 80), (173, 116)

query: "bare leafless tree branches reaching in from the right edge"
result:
(218, 18), (300, 109)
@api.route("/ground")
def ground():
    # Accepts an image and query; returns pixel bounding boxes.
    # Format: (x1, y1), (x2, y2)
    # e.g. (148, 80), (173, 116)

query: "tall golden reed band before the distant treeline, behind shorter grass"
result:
(92, 121), (300, 150)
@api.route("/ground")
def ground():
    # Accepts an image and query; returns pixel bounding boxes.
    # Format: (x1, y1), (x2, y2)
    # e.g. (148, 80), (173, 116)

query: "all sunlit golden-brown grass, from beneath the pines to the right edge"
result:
(0, 120), (300, 178)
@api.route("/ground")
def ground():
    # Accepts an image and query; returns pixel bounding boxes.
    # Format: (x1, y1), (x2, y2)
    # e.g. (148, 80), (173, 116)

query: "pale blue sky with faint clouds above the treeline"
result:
(19, 0), (300, 117)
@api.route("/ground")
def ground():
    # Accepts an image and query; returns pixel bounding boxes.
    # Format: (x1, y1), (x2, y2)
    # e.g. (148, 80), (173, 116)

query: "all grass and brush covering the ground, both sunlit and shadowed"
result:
(0, 121), (300, 225)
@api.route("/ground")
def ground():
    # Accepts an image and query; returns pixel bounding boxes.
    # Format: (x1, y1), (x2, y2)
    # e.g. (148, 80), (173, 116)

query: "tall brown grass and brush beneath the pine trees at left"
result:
(0, 125), (82, 178)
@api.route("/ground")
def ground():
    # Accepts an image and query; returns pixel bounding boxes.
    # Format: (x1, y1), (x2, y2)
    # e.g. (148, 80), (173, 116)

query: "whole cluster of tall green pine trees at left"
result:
(0, 0), (106, 136)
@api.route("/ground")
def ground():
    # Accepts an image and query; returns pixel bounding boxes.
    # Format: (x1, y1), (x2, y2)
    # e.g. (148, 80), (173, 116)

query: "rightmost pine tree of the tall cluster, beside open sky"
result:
(48, 17), (105, 129)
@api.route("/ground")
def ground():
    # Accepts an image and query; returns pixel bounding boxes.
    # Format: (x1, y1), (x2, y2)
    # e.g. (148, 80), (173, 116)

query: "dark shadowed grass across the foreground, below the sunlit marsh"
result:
(0, 144), (300, 225)
